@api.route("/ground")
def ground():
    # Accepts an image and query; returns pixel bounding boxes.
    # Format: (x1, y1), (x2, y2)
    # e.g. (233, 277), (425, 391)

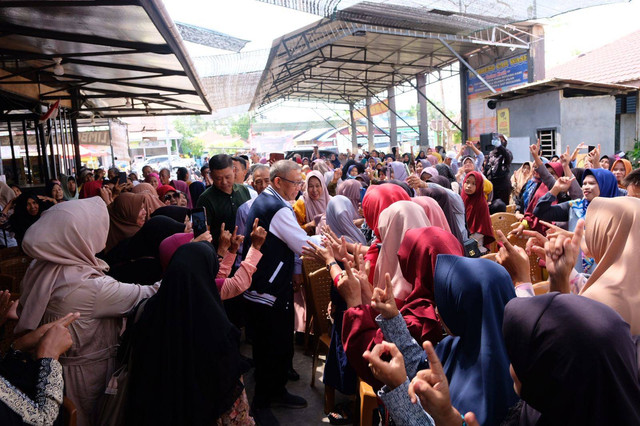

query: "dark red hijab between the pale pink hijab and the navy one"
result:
(397, 226), (464, 343)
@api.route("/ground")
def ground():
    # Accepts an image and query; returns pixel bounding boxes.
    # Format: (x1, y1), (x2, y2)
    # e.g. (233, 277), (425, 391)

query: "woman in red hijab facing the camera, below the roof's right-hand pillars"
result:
(462, 171), (495, 253)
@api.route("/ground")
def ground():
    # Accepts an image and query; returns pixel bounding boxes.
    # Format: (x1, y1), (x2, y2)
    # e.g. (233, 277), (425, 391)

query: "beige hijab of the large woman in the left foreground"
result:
(15, 197), (109, 333)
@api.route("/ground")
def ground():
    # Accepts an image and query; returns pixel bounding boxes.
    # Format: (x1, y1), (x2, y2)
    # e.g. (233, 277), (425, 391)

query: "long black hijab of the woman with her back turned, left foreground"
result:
(126, 242), (246, 426)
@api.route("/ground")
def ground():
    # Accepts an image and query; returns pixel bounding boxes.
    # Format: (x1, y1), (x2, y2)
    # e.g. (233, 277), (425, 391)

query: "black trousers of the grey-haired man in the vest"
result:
(247, 297), (293, 408)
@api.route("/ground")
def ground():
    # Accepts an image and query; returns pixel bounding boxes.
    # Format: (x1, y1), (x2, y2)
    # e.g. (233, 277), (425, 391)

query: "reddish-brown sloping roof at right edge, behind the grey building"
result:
(546, 30), (640, 85)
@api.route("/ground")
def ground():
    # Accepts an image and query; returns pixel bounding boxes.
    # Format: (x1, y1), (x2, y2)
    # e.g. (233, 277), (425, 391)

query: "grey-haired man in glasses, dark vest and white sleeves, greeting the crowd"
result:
(244, 160), (319, 425)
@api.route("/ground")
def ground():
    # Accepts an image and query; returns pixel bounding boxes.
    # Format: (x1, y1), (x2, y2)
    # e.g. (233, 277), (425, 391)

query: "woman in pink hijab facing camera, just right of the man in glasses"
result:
(293, 170), (331, 235)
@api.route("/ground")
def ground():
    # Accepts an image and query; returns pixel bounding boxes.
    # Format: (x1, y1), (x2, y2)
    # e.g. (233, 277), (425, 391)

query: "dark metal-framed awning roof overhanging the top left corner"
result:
(0, 0), (211, 117)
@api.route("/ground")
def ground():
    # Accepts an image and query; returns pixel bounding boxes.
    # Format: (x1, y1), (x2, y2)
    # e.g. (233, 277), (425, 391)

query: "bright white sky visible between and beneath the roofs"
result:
(164, 0), (640, 122)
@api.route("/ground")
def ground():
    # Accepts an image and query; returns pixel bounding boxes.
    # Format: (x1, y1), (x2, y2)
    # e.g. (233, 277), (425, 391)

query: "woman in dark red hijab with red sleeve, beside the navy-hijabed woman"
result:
(342, 227), (463, 388)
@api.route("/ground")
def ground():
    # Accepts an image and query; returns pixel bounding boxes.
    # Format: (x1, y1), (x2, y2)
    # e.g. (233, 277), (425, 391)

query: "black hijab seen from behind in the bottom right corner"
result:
(502, 292), (640, 425)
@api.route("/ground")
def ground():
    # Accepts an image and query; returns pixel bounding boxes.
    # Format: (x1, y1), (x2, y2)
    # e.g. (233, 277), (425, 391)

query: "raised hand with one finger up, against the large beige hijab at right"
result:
(544, 219), (584, 293)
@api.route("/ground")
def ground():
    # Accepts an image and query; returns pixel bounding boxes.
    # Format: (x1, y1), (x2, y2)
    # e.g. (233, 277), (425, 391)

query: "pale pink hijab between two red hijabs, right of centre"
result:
(373, 201), (431, 300)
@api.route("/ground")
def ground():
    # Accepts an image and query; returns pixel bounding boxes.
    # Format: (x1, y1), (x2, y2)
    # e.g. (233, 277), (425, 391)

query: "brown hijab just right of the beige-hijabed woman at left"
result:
(105, 191), (147, 253)
